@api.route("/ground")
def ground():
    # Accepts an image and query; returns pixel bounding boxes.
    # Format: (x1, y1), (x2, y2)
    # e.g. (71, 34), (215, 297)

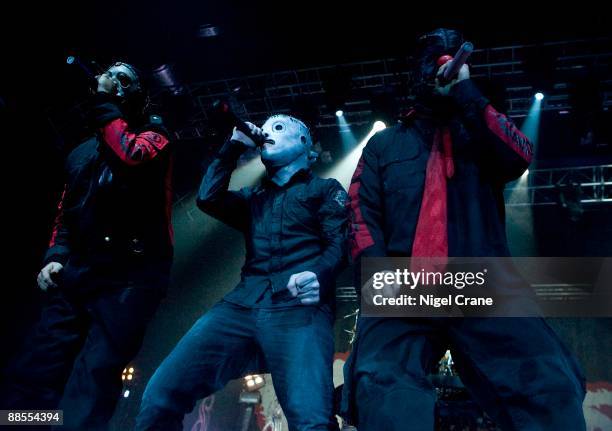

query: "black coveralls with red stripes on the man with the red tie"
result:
(343, 80), (585, 431)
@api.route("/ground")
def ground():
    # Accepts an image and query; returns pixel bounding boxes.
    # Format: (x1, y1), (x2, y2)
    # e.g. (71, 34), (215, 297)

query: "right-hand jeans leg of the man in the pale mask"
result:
(257, 307), (338, 431)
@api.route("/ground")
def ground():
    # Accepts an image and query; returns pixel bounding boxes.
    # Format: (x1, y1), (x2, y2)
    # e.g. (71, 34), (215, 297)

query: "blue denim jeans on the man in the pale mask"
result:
(136, 301), (337, 431)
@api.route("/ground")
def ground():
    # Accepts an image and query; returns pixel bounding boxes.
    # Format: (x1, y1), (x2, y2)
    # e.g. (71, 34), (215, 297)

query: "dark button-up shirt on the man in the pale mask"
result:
(197, 142), (348, 307)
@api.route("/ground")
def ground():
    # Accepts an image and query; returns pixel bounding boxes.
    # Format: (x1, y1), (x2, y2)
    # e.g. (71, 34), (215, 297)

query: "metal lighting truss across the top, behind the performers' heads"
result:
(173, 38), (612, 138)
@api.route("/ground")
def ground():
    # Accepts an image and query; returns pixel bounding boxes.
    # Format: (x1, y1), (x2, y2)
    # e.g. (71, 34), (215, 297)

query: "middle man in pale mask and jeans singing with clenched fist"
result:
(137, 115), (347, 431)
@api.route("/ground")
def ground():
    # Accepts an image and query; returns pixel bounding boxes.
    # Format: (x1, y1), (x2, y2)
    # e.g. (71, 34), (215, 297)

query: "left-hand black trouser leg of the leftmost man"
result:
(0, 293), (89, 410)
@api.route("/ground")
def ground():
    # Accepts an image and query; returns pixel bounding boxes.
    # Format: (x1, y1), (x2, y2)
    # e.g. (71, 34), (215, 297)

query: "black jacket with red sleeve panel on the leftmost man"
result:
(44, 94), (173, 287)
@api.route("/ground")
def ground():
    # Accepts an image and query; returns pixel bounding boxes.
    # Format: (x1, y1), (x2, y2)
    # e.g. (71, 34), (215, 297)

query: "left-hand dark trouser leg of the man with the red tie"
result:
(343, 317), (444, 431)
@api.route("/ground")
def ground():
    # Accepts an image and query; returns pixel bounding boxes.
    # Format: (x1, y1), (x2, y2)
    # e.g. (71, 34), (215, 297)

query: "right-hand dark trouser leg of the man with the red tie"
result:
(449, 318), (585, 431)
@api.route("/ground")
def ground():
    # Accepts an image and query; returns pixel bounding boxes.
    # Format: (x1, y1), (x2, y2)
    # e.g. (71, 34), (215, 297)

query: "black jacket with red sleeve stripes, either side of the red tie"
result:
(349, 80), (533, 260)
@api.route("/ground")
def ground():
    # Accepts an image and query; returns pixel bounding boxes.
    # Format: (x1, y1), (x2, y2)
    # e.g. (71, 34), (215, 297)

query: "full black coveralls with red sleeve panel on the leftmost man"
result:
(2, 94), (173, 431)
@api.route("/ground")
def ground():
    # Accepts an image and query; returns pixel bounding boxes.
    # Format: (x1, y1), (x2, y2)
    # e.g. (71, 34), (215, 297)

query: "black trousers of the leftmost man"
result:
(2, 283), (163, 431)
